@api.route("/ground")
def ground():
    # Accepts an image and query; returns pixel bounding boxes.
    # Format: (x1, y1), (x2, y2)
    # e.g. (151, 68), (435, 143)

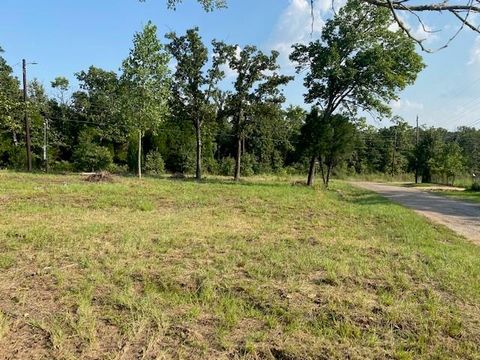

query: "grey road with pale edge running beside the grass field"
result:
(352, 182), (480, 245)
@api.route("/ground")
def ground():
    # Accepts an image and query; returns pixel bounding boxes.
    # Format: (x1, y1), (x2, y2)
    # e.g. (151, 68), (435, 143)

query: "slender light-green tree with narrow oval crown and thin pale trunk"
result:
(121, 22), (170, 178)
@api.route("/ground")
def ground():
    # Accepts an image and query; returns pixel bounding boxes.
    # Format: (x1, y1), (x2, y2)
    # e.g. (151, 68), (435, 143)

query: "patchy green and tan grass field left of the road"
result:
(0, 172), (480, 359)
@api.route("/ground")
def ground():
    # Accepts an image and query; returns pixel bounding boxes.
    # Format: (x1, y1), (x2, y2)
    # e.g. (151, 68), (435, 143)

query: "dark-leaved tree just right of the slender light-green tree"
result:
(167, 28), (225, 180)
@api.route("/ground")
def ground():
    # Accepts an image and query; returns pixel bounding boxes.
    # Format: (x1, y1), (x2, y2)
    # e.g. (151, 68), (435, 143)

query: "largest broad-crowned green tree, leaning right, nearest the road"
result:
(290, 0), (424, 184)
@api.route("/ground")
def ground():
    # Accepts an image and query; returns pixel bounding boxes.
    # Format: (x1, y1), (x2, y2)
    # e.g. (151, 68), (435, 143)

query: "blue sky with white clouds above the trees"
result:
(0, 0), (480, 129)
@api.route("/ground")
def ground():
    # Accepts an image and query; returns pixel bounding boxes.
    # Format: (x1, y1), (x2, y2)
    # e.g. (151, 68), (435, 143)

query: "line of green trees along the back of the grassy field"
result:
(0, 0), (478, 185)
